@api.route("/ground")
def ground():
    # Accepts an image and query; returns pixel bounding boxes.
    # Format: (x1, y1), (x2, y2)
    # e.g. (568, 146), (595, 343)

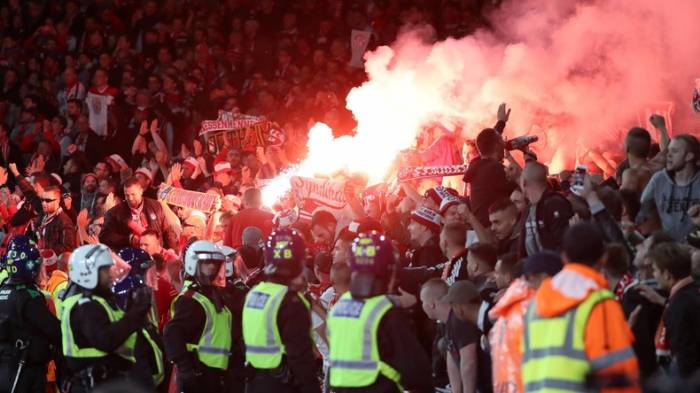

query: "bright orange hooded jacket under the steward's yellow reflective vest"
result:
(534, 263), (641, 393)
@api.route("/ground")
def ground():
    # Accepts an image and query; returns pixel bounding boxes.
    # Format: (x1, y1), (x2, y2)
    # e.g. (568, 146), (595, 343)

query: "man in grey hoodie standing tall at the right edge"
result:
(638, 134), (700, 241)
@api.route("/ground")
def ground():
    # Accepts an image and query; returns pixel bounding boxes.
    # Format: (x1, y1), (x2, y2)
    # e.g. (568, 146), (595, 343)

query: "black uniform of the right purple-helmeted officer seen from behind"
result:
(331, 307), (434, 393)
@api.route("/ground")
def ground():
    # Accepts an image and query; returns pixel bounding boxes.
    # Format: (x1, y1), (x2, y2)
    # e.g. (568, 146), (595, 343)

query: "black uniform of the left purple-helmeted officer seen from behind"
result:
(246, 290), (321, 393)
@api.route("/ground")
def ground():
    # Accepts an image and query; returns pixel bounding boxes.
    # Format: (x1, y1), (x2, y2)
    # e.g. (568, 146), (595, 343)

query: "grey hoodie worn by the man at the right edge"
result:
(637, 170), (700, 241)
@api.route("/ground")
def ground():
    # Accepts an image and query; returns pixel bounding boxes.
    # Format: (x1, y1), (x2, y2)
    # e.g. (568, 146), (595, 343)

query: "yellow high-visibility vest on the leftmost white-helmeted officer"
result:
(61, 294), (136, 363)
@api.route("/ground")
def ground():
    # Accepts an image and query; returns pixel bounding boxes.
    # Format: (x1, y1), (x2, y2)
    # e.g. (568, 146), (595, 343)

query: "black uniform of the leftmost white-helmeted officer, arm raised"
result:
(66, 288), (149, 392)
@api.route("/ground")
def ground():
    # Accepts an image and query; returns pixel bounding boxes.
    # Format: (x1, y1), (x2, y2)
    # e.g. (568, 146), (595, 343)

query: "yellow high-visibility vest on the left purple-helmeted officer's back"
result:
(243, 281), (310, 369)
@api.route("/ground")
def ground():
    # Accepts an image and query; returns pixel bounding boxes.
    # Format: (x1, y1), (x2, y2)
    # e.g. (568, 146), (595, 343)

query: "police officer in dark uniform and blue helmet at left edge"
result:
(0, 236), (61, 393)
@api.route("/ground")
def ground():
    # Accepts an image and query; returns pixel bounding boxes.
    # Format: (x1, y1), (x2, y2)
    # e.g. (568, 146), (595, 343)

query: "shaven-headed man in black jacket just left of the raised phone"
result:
(520, 162), (574, 256)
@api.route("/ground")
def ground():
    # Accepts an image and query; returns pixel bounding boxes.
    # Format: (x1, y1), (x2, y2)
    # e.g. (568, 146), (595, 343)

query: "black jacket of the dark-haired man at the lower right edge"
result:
(664, 280), (700, 378)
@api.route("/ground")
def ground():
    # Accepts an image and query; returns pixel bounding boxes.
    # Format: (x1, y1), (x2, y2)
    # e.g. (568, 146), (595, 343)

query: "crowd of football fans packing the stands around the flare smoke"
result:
(0, 0), (700, 392)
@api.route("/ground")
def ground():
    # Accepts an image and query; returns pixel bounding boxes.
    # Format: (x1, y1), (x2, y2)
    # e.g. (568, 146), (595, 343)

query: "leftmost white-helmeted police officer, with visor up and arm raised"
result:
(61, 244), (151, 393)
